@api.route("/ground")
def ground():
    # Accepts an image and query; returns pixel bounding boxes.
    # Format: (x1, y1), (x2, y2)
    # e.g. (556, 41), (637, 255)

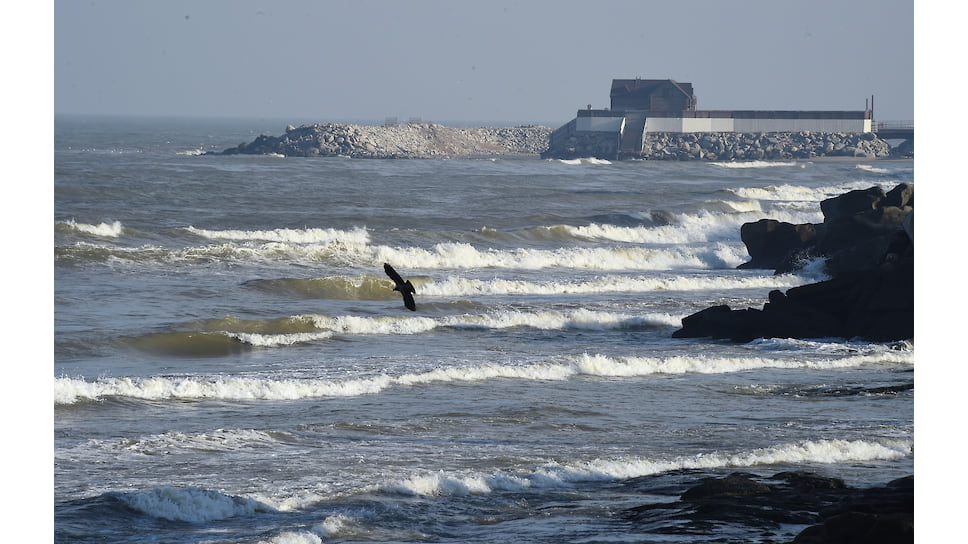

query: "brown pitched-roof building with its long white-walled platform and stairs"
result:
(547, 78), (874, 158)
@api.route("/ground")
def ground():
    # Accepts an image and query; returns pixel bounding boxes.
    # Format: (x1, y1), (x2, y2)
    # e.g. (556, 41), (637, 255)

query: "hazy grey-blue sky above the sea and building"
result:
(54, 0), (914, 124)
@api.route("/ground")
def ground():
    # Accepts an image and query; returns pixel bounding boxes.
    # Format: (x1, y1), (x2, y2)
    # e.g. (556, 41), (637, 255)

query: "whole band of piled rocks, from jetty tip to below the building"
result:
(209, 123), (913, 161)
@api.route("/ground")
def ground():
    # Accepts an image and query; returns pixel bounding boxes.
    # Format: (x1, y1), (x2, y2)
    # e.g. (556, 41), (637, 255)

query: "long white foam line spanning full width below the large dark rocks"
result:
(54, 351), (914, 404)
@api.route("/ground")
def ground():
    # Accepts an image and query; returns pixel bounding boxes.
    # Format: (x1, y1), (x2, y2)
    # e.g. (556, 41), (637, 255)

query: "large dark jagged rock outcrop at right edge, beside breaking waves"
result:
(673, 183), (914, 342)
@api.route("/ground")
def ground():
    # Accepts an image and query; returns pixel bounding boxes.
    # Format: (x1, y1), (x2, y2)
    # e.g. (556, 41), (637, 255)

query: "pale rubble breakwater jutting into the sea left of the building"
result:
(215, 123), (551, 159)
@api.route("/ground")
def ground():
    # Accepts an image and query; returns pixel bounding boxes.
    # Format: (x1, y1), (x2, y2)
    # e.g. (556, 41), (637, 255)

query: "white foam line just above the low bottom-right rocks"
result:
(378, 440), (914, 496)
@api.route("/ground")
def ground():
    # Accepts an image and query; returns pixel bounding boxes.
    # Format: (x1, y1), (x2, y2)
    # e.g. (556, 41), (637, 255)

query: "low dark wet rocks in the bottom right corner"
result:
(623, 471), (914, 544)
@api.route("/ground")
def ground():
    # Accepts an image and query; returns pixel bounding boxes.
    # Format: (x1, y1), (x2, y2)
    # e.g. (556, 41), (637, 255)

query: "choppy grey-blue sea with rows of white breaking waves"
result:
(53, 117), (914, 544)
